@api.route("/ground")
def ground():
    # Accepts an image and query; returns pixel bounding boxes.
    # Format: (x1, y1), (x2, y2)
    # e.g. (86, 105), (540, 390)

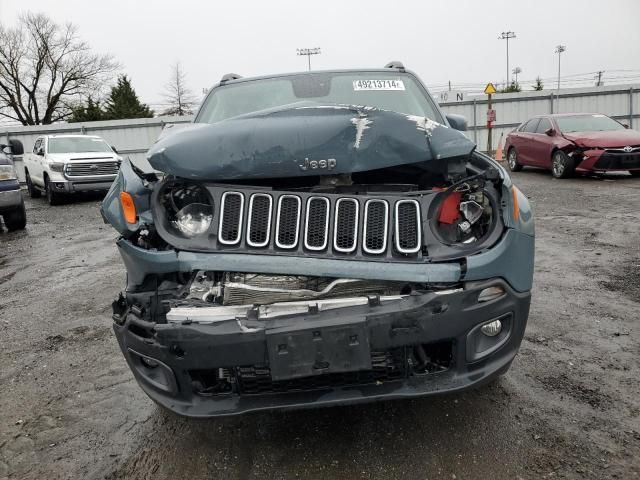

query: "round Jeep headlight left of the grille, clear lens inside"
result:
(162, 183), (213, 238)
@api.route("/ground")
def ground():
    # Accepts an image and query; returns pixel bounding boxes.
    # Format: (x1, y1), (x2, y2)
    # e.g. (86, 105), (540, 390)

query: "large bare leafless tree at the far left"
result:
(0, 13), (118, 125)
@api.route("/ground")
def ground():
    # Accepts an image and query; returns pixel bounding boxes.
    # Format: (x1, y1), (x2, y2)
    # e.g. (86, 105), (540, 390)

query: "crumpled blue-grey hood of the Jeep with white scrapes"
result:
(147, 104), (475, 180)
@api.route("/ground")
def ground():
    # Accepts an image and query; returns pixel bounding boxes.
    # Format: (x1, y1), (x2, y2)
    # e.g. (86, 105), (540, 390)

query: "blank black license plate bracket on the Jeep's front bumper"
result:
(266, 319), (371, 381)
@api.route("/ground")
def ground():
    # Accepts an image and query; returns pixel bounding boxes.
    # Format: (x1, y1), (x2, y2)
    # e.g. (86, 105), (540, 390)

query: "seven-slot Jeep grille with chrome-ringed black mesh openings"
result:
(218, 191), (422, 255)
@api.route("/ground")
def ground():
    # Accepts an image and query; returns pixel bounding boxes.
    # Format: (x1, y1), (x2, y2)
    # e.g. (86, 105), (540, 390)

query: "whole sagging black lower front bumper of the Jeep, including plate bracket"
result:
(114, 279), (530, 417)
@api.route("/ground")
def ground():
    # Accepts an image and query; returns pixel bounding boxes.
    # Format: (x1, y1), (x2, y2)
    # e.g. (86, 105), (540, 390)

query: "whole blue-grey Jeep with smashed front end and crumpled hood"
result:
(102, 62), (534, 417)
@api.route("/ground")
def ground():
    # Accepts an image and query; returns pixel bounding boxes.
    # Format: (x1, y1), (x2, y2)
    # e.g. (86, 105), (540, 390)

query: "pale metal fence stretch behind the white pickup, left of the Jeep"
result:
(0, 117), (192, 182)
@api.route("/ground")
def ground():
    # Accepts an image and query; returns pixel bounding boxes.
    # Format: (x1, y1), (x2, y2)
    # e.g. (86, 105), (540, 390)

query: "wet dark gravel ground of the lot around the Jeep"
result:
(0, 170), (640, 480)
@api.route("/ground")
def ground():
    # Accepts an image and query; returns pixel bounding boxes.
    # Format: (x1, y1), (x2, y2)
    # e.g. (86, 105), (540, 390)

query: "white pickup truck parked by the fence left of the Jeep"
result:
(23, 135), (122, 205)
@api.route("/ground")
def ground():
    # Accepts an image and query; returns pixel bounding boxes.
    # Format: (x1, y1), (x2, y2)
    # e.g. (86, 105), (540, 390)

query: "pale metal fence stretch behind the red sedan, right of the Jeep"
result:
(440, 85), (640, 151)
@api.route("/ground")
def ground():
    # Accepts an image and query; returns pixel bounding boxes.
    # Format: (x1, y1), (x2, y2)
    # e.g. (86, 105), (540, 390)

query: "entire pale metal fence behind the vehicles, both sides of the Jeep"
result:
(5, 85), (640, 181)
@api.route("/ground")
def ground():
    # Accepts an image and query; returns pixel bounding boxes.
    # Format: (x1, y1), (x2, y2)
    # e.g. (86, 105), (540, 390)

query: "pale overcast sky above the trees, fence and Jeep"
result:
(0, 0), (640, 109)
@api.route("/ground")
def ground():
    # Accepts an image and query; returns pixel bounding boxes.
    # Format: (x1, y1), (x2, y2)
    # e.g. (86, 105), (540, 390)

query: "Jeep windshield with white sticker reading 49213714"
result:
(196, 72), (443, 123)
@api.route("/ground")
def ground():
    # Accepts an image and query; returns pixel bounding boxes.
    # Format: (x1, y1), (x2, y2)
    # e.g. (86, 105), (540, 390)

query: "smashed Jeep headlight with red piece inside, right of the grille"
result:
(434, 178), (498, 245)
